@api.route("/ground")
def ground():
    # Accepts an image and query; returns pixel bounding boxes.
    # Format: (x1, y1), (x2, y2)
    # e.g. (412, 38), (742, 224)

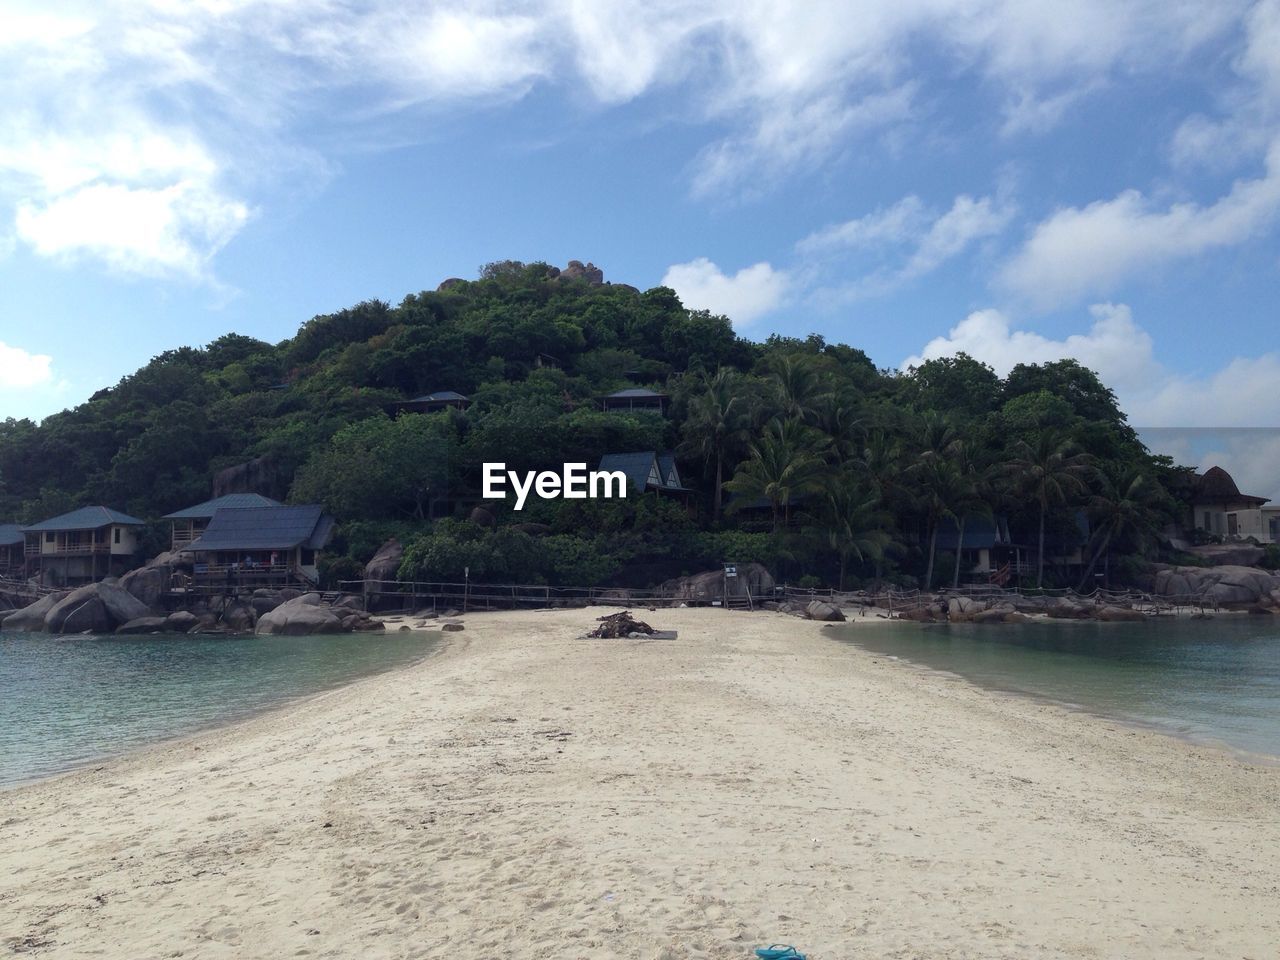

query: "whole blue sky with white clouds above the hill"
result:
(0, 0), (1280, 485)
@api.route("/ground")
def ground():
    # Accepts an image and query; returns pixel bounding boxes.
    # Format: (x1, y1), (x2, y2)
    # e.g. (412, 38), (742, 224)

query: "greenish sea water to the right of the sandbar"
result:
(832, 616), (1280, 756)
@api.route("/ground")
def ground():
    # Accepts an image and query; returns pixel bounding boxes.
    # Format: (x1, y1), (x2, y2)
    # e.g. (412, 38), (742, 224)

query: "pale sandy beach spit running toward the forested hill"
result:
(0, 609), (1280, 960)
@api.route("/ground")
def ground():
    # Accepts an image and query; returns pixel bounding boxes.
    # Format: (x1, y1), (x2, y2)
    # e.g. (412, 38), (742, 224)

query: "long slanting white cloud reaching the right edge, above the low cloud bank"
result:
(1000, 141), (1280, 307)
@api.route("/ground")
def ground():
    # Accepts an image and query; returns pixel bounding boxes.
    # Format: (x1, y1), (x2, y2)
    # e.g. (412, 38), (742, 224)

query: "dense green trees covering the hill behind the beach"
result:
(0, 261), (1189, 585)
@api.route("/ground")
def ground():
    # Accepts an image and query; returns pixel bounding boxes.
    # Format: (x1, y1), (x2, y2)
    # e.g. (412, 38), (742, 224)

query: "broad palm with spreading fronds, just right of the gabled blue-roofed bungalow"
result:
(724, 420), (827, 532)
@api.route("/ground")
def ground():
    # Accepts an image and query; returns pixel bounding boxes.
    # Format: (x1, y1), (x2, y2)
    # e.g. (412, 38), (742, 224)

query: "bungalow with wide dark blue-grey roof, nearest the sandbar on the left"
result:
(186, 504), (333, 585)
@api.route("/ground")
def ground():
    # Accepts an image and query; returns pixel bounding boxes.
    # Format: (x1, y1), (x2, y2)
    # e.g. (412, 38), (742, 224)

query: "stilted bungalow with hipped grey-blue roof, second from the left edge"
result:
(22, 506), (146, 586)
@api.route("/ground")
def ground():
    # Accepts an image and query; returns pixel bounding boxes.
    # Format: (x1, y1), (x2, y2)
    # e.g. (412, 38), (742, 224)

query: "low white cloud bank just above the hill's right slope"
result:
(901, 303), (1280, 428)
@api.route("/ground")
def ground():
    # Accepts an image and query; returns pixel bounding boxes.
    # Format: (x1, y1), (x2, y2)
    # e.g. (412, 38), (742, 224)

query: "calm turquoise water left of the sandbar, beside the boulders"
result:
(0, 631), (439, 786)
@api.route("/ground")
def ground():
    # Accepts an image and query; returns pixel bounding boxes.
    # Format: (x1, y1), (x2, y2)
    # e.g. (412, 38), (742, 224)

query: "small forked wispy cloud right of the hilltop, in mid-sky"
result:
(796, 195), (1014, 302)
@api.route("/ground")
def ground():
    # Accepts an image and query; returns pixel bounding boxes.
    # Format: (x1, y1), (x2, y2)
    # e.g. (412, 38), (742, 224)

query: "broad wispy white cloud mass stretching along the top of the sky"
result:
(0, 0), (1249, 285)
